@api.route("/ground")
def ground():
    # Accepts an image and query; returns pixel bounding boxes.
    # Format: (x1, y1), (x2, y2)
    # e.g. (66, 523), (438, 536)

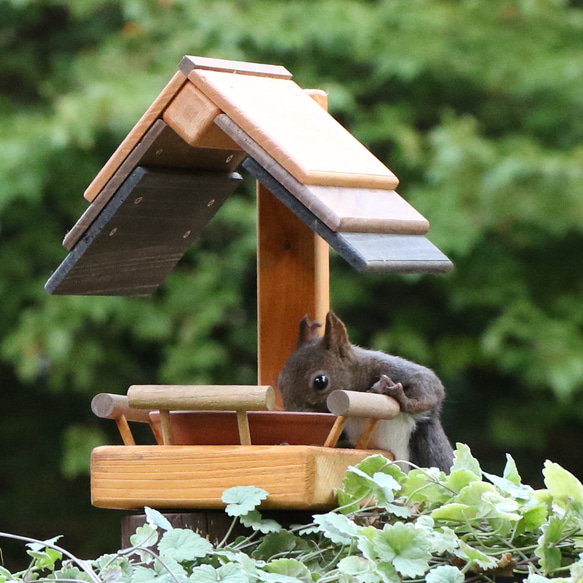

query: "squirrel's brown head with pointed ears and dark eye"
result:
(278, 312), (356, 412)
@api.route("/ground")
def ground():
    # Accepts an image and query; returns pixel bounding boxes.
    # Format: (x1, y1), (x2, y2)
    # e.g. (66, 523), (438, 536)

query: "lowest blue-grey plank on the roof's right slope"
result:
(243, 158), (453, 276)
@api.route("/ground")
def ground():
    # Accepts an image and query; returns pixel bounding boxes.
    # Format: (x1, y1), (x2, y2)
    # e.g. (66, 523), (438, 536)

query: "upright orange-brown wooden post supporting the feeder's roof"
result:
(257, 91), (330, 406)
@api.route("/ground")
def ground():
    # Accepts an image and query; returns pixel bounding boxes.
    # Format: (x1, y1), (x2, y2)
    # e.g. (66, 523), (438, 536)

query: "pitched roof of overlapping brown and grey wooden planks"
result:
(45, 56), (452, 295)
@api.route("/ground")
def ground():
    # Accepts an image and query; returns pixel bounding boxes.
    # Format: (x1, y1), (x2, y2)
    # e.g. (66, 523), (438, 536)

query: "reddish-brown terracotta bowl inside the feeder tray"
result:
(150, 411), (336, 445)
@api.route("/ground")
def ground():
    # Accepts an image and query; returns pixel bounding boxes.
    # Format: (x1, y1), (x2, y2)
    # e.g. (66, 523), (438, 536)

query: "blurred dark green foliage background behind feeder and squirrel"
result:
(0, 0), (583, 562)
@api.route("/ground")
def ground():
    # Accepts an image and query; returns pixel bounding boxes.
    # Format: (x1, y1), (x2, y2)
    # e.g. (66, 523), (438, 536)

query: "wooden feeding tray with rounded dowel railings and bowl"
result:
(91, 385), (399, 510)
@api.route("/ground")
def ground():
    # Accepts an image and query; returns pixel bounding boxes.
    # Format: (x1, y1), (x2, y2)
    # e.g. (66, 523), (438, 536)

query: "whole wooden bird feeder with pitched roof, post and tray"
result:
(45, 56), (452, 509)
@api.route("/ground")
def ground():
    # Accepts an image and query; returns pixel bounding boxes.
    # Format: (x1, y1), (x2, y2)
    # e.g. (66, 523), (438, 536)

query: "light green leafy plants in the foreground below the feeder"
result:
(5, 452), (583, 583)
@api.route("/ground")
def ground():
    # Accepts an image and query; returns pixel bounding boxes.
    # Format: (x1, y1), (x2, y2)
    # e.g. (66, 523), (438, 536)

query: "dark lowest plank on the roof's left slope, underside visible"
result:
(45, 167), (241, 295)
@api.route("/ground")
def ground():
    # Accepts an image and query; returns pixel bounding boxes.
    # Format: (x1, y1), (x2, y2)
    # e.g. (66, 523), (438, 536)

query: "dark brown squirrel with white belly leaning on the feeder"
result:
(278, 312), (453, 472)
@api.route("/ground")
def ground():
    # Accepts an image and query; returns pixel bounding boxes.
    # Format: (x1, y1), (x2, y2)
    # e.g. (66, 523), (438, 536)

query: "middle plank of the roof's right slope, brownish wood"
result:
(215, 114), (429, 235)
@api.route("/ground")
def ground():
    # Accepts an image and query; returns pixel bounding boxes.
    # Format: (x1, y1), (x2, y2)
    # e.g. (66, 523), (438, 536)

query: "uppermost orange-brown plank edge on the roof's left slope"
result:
(83, 71), (186, 202)
